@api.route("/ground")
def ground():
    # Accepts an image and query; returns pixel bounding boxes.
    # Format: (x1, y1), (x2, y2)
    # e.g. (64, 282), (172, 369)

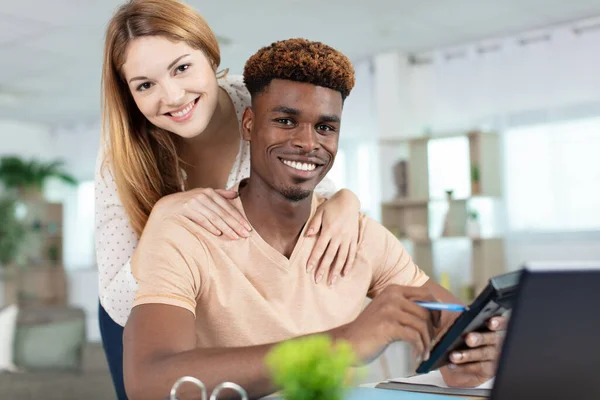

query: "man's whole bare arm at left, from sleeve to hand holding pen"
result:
(123, 285), (438, 400)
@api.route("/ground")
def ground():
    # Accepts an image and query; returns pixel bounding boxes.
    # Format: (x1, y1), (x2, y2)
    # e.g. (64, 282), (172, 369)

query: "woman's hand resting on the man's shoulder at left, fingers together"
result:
(151, 188), (252, 239)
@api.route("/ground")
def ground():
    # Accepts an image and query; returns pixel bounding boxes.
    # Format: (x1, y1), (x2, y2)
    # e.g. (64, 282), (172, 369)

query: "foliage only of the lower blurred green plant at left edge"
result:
(0, 197), (25, 265)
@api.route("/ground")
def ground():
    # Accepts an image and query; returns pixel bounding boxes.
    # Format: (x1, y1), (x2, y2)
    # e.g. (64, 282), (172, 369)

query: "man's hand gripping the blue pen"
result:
(337, 285), (440, 362)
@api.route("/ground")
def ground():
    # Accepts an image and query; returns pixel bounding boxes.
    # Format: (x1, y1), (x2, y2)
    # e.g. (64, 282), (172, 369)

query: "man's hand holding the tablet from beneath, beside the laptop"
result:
(440, 317), (508, 387)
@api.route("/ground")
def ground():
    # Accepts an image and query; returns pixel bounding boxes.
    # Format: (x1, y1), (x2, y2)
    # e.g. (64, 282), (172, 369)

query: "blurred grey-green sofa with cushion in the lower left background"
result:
(0, 306), (115, 400)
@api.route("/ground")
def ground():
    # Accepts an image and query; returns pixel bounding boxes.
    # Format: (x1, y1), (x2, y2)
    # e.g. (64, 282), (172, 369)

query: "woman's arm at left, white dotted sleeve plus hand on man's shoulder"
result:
(95, 142), (251, 326)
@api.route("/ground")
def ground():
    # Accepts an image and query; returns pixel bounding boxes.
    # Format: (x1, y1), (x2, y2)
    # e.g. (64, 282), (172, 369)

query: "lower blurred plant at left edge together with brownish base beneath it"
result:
(0, 196), (25, 304)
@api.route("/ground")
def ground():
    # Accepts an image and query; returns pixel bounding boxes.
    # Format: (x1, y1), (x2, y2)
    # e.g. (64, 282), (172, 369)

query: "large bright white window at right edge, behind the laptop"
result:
(504, 118), (600, 232)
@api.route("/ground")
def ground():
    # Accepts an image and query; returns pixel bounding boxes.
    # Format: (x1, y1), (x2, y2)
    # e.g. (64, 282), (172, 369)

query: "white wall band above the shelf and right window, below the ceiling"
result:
(375, 16), (600, 137)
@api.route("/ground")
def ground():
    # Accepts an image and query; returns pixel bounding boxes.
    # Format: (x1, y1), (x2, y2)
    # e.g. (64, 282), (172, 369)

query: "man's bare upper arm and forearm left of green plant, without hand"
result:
(123, 304), (274, 400)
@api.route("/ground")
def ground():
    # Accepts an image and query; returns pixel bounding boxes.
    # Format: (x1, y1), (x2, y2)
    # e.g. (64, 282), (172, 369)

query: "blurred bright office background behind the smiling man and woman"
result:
(0, 0), (600, 399)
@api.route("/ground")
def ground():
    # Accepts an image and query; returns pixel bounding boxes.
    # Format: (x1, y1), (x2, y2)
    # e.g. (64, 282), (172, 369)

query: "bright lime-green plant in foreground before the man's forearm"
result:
(266, 335), (356, 400)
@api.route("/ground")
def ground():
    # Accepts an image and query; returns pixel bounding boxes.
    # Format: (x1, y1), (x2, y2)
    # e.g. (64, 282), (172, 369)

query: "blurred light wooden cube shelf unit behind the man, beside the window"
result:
(379, 131), (506, 296)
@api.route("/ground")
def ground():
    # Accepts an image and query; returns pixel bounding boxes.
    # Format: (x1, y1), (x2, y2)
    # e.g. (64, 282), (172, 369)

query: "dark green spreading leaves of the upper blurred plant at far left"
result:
(0, 156), (77, 191)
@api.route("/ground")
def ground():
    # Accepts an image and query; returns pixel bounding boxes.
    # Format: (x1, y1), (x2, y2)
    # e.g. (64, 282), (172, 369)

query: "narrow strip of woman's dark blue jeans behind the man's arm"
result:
(98, 302), (127, 400)
